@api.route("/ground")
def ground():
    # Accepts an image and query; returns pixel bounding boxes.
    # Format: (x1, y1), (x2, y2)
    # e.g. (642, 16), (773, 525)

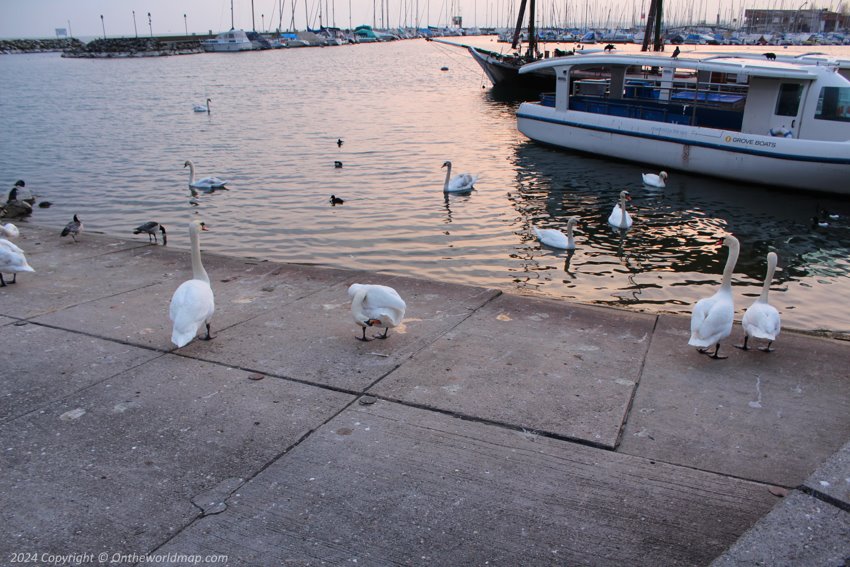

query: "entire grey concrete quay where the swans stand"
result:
(0, 223), (850, 567)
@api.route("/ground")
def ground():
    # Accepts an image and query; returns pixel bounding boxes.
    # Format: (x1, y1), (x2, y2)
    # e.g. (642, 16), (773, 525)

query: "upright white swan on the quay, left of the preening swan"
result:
(168, 220), (215, 348)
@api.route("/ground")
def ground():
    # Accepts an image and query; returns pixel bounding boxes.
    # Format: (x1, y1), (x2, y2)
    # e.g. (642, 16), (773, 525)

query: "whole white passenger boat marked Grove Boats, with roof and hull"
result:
(517, 55), (850, 194)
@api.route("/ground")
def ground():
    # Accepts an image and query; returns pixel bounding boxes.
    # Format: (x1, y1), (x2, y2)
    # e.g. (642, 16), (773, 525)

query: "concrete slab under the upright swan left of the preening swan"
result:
(33, 256), (350, 351)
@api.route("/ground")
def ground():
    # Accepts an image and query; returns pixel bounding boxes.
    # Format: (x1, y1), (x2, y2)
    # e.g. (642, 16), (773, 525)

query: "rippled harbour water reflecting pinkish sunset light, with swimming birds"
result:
(0, 38), (850, 332)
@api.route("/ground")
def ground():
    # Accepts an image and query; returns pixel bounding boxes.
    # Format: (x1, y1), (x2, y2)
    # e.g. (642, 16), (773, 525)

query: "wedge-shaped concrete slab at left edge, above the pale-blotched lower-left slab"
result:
(0, 323), (161, 423)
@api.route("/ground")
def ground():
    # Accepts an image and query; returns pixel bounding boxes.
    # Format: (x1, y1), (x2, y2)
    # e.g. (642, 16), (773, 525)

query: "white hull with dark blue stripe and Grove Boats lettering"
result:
(517, 103), (850, 194)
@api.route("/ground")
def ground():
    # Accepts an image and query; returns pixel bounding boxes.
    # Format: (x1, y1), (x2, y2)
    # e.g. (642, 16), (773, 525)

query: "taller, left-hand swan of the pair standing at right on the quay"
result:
(688, 234), (741, 358)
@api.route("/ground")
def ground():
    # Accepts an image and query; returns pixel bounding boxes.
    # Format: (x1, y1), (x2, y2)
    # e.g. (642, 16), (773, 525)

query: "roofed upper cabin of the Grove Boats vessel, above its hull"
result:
(523, 55), (850, 141)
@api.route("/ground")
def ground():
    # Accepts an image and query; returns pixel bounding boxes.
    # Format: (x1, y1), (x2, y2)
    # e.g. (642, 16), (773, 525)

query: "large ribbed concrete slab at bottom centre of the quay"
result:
(152, 400), (775, 566)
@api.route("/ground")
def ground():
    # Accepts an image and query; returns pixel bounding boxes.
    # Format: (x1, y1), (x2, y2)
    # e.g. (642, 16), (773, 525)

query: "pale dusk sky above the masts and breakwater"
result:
(0, 0), (850, 39)
